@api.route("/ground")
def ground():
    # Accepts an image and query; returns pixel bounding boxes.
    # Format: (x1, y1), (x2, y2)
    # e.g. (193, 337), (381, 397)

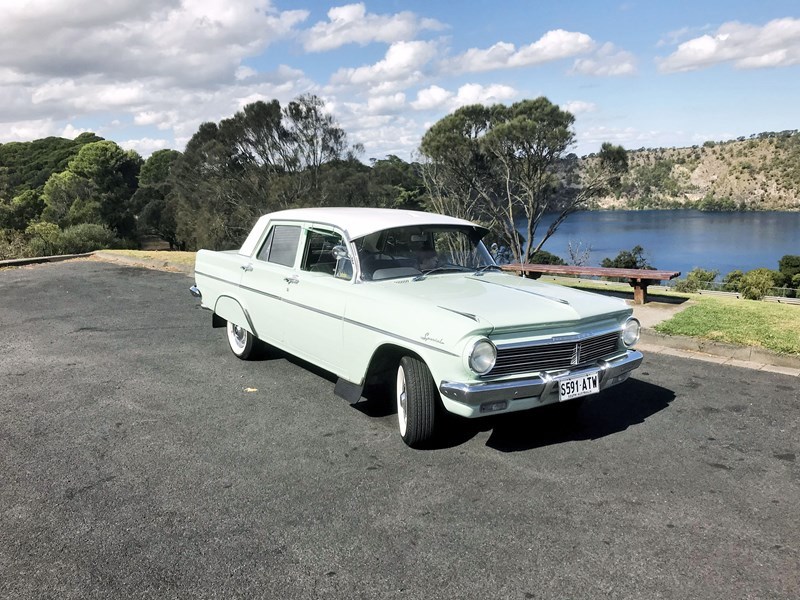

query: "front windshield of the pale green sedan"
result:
(354, 225), (494, 281)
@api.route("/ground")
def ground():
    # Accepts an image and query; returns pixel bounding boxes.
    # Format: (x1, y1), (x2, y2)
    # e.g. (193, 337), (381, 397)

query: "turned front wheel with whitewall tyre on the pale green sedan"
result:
(397, 356), (436, 448)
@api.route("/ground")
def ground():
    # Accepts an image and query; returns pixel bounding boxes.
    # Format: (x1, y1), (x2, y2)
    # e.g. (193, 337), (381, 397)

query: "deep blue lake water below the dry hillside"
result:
(524, 210), (800, 275)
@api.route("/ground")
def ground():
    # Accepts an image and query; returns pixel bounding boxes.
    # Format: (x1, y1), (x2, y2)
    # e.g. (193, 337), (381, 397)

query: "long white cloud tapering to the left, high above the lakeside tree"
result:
(447, 29), (595, 73)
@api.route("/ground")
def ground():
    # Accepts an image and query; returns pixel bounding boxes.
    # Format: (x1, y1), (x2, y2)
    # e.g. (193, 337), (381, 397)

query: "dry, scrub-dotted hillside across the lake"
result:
(585, 130), (800, 210)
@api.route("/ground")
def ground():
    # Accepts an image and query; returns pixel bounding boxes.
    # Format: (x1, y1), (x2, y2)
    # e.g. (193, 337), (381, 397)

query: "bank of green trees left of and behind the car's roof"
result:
(0, 96), (425, 259)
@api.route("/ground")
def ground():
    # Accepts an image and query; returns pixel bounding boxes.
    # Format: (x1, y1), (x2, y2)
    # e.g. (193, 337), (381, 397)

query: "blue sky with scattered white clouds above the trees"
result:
(0, 0), (800, 160)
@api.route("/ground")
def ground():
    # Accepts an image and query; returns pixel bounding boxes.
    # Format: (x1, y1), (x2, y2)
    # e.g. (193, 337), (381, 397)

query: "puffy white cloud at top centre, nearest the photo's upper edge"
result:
(302, 3), (444, 52)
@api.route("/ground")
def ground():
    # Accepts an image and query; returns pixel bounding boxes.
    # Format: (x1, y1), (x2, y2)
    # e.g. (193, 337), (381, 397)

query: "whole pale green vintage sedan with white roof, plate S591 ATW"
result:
(191, 208), (642, 447)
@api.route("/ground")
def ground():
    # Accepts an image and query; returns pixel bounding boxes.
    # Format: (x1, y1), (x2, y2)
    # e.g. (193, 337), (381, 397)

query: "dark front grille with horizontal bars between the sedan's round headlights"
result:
(486, 331), (619, 377)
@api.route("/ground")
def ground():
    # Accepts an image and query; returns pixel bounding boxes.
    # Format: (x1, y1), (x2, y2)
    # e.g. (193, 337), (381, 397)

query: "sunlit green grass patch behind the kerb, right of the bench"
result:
(655, 296), (800, 355)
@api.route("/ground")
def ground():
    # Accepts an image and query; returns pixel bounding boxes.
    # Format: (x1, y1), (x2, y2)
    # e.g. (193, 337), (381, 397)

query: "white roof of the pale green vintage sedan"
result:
(243, 207), (484, 248)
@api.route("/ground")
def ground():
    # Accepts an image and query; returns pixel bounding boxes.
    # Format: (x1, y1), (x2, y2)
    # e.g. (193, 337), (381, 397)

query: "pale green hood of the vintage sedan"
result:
(381, 273), (631, 332)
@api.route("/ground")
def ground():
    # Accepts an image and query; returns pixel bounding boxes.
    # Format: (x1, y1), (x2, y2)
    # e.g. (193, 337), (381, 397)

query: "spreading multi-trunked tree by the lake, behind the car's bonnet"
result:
(420, 97), (627, 261)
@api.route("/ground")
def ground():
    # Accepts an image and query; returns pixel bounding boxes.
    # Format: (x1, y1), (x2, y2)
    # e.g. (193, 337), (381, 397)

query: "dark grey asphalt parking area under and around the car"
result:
(0, 260), (800, 600)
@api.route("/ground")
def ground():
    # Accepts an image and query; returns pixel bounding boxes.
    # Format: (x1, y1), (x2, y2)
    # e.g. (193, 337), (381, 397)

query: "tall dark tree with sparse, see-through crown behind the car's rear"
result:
(171, 95), (356, 249)
